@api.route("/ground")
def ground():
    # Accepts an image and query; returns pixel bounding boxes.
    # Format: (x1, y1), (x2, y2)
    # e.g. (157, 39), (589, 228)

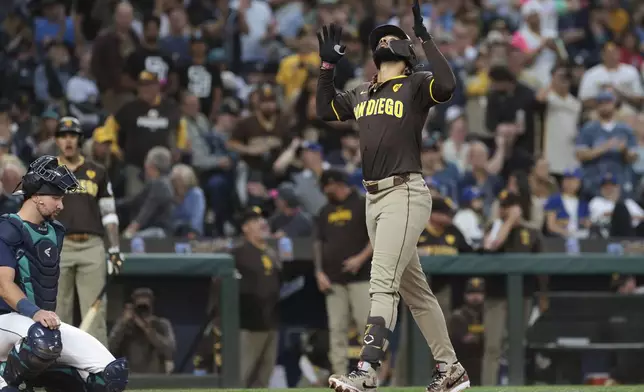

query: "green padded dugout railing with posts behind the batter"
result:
(110, 253), (644, 388)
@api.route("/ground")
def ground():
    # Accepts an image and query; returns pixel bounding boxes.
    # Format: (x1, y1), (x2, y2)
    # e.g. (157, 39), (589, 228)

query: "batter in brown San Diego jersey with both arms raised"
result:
(316, 0), (470, 392)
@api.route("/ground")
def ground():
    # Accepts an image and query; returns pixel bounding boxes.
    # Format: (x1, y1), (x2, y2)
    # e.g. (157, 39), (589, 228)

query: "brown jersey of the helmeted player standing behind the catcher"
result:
(56, 158), (114, 237)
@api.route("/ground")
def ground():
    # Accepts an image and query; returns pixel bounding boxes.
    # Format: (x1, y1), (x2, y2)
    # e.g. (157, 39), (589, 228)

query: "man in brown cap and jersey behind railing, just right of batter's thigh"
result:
(418, 197), (473, 318)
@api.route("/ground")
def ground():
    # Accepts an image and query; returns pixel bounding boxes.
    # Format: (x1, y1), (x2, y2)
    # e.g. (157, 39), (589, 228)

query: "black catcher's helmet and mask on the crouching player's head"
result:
(14, 155), (82, 200)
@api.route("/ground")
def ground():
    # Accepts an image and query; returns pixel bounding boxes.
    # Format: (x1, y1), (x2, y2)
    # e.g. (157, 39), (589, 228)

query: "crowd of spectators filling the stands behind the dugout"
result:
(0, 0), (644, 386)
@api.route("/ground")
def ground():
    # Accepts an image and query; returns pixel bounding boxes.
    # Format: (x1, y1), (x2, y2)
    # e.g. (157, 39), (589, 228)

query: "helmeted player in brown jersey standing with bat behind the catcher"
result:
(56, 117), (122, 345)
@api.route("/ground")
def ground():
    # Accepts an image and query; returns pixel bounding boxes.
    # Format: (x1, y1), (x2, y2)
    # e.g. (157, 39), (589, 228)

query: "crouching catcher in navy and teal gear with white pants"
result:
(0, 155), (128, 392)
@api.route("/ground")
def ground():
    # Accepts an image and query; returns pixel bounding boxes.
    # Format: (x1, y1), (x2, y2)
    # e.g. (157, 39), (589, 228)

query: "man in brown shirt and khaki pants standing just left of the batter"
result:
(313, 169), (372, 373)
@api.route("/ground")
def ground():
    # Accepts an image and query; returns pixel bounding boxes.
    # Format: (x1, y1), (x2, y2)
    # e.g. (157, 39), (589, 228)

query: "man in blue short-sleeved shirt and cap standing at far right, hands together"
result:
(577, 92), (637, 195)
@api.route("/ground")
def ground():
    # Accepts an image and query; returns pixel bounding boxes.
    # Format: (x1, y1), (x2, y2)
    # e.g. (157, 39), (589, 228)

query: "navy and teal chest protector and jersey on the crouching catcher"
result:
(0, 214), (65, 313)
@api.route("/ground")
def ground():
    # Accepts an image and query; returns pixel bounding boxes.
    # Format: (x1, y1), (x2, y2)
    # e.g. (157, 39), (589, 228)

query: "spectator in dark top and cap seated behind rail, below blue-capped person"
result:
(268, 183), (313, 238)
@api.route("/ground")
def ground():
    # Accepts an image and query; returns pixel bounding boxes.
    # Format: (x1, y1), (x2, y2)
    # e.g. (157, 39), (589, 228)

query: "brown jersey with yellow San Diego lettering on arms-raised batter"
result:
(331, 72), (441, 181)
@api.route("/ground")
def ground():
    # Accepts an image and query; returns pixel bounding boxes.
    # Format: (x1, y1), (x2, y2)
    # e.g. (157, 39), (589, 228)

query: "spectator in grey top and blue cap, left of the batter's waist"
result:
(292, 142), (330, 216)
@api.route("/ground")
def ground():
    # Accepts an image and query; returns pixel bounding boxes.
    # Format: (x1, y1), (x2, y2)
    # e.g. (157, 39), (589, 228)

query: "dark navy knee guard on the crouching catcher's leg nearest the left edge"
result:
(0, 324), (63, 387)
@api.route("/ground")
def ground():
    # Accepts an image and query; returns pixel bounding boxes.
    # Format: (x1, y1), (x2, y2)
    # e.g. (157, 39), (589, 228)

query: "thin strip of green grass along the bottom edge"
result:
(128, 385), (644, 392)
